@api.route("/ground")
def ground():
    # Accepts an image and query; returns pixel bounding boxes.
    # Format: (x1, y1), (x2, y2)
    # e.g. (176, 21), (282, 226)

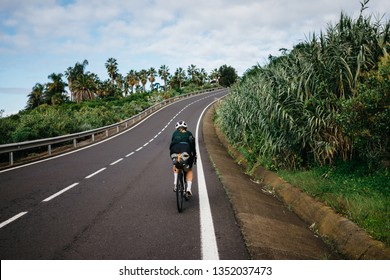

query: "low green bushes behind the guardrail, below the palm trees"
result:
(0, 93), (162, 144)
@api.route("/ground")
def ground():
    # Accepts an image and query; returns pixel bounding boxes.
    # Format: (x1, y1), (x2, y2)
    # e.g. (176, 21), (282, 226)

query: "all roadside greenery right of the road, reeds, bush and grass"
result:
(217, 0), (390, 245)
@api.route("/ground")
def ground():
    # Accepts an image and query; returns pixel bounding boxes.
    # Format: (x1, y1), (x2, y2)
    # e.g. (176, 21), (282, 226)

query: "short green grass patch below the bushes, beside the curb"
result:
(278, 162), (390, 246)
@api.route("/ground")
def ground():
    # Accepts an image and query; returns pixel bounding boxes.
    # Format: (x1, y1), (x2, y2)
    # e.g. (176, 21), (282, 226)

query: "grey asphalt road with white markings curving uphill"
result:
(0, 90), (248, 260)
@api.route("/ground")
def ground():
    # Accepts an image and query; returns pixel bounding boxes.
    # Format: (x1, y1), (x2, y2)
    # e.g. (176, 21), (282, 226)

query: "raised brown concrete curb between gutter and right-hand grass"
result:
(209, 105), (390, 260)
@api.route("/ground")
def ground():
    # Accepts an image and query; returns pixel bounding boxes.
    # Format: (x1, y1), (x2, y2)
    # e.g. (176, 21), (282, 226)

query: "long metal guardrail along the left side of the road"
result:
(0, 88), (220, 167)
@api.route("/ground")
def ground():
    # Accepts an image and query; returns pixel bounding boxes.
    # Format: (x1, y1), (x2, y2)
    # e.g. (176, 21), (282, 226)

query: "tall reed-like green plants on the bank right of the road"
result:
(218, 3), (390, 168)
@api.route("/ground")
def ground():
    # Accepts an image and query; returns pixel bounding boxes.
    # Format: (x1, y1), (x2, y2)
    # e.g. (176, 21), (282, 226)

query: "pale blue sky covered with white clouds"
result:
(0, 0), (390, 117)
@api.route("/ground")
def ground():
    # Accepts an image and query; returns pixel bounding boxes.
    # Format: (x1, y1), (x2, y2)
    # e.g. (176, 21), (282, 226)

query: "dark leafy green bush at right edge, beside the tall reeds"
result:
(338, 55), (390, 168)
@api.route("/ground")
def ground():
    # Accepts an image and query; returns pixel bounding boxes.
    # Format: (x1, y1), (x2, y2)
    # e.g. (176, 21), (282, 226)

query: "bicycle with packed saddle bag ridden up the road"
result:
(171, 152), (190, 213)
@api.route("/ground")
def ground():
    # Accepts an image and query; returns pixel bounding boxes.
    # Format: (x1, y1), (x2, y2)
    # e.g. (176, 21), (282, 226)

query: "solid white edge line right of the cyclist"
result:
(195, 101), (219, 260)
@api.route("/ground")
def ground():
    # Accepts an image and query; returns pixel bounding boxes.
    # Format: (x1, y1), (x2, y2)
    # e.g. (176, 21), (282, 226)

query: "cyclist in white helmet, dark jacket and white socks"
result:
(169, 121), (196, 196)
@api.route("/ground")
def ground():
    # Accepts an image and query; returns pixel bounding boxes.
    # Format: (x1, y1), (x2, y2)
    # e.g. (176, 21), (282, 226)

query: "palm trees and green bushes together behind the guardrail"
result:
(0, 63), (238, 144)
